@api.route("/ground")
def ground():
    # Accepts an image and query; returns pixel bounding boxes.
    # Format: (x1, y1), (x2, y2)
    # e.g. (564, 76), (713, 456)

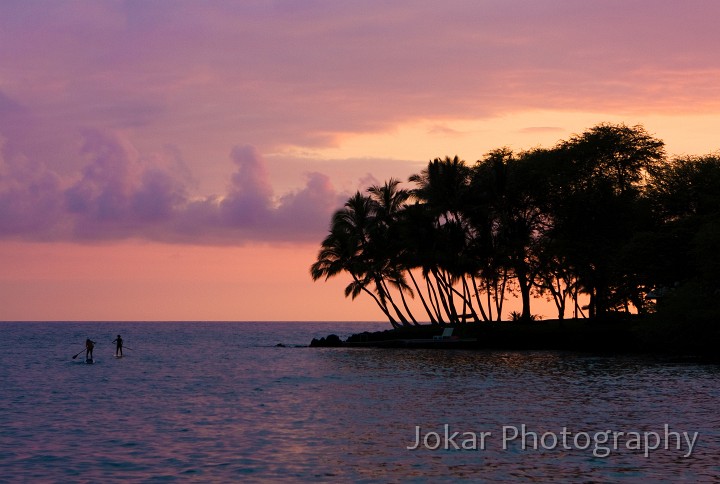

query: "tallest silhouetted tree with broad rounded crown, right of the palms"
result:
(550, 124), (665, 317)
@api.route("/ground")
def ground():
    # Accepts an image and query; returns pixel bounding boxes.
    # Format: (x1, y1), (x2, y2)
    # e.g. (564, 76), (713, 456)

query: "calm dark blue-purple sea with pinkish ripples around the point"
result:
(0, 322), (720, 482)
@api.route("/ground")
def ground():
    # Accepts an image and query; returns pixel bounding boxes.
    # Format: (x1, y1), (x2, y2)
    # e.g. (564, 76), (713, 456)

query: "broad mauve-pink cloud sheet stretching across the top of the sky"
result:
(0, 0), (720, 164)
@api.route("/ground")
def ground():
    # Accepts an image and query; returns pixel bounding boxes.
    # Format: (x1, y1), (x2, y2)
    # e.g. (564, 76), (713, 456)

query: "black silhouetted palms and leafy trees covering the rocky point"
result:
(310, 124), (720, 354)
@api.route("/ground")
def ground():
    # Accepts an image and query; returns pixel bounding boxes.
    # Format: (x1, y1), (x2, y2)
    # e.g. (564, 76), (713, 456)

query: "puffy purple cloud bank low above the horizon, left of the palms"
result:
(0, 126), (347, 244)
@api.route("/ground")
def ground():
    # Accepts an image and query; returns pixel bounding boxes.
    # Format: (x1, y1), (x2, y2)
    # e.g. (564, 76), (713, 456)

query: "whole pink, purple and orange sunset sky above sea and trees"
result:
(0, 0), (720, 321)
